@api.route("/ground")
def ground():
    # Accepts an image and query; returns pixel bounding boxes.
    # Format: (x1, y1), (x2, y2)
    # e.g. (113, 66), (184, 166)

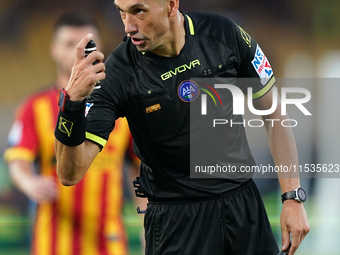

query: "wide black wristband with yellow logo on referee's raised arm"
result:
(54, 103), (87, 146)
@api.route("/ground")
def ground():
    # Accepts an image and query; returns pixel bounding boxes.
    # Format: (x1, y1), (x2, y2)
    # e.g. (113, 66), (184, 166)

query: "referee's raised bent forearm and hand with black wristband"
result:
(55, 34), (105, 186)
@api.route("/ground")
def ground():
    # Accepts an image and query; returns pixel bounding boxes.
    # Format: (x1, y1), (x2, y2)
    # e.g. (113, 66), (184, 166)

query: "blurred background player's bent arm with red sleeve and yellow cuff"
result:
(3, 97), (57, 203)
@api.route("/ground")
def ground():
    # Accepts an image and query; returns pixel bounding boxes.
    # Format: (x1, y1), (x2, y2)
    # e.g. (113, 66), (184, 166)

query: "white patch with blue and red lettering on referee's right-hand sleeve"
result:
(251, 45), (273, 85)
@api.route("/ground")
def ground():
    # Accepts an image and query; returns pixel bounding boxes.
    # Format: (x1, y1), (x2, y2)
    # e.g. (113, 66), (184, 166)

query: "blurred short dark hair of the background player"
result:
(53, 11), (99, 34)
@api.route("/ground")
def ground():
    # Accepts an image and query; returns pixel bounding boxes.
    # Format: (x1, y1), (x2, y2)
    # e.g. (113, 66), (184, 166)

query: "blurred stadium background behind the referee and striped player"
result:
(0, 0), (340, 255)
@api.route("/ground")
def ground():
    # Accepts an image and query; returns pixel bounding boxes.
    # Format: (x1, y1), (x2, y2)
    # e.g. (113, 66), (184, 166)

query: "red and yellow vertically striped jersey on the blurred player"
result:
(4, 88), (137, 255)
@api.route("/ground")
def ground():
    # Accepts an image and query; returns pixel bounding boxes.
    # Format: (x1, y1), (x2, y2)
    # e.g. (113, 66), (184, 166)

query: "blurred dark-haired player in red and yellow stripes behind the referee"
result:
(4, 13), (138, 255)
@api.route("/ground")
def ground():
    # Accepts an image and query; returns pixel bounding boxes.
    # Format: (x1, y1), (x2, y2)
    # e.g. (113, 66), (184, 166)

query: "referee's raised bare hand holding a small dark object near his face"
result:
(66, 34), (105, 101)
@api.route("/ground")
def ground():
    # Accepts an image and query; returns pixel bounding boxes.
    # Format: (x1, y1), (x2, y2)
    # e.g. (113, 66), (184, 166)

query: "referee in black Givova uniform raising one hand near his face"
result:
(55, 0), (309, 255)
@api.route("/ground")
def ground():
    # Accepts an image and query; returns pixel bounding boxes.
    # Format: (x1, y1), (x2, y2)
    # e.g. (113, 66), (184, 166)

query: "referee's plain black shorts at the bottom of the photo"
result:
(144, 180), (279, 255)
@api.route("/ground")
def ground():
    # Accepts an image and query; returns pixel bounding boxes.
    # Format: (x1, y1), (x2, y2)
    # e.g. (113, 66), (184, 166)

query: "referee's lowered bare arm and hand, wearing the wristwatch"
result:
(254, 89), (310, 255)
